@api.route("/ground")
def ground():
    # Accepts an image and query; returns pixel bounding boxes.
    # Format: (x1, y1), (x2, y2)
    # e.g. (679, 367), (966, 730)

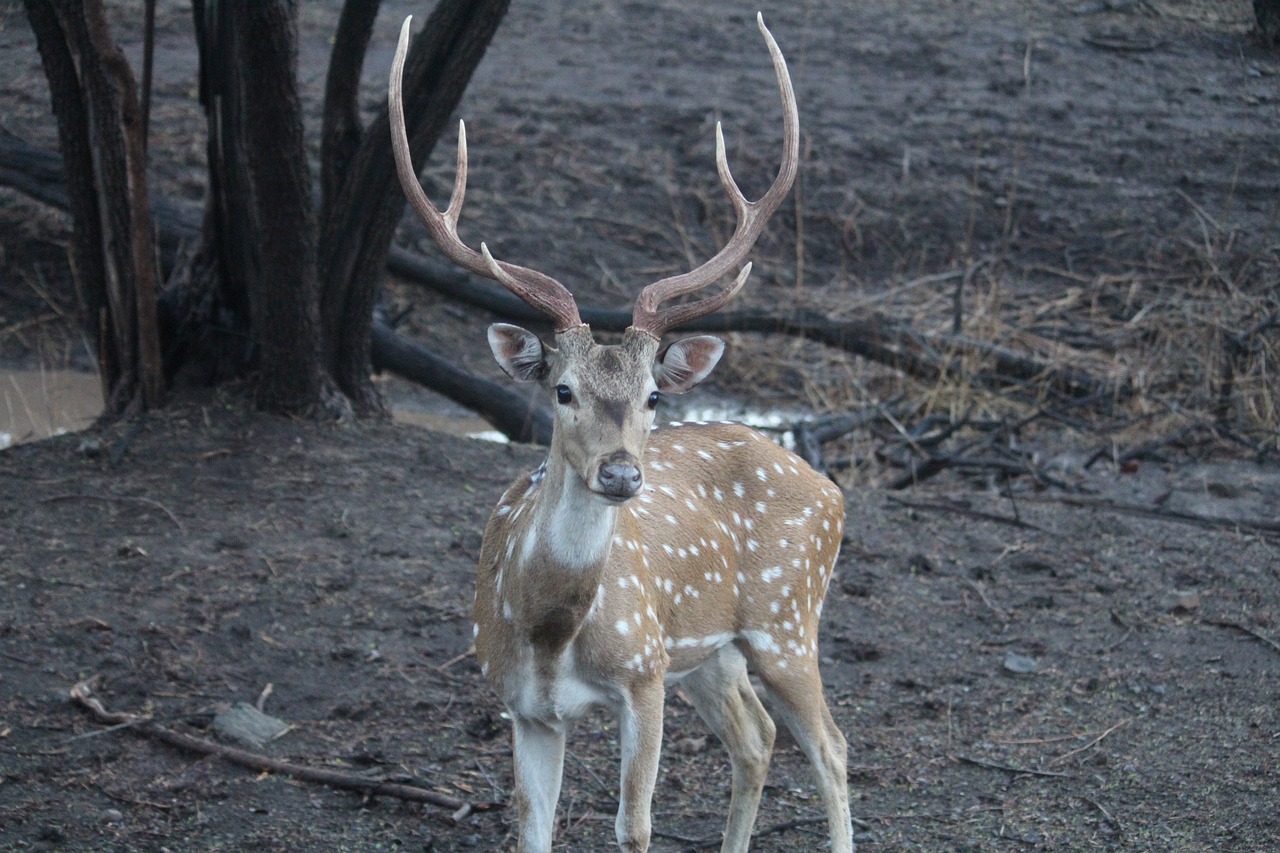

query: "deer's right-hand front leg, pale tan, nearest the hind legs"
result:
(614, 678), (664, 853)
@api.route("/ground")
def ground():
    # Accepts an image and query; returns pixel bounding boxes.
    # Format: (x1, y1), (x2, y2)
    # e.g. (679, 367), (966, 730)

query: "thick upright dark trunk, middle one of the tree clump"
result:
(195, 0), (346, 416)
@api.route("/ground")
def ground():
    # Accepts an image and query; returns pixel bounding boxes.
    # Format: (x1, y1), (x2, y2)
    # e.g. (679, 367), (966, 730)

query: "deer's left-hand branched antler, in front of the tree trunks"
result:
(387, 15), (582, 332)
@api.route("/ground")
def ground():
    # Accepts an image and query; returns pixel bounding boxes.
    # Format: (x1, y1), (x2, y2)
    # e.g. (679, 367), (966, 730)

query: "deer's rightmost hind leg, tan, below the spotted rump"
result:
(756, 660), (854, 853)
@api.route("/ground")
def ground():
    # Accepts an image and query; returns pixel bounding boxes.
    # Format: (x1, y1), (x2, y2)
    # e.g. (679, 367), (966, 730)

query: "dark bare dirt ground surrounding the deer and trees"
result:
(0, 0), (1280, 852)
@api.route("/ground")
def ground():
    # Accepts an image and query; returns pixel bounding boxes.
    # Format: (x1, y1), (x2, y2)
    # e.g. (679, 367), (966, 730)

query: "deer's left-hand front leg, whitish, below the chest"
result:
(511, 713), (564, 853)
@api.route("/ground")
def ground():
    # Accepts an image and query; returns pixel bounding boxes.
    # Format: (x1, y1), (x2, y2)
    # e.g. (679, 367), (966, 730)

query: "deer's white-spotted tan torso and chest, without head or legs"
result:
(475, 424), (844, 701)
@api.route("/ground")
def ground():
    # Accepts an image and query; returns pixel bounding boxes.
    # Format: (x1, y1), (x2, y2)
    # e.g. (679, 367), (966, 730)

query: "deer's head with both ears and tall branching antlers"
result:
(388, 9), (800, 502)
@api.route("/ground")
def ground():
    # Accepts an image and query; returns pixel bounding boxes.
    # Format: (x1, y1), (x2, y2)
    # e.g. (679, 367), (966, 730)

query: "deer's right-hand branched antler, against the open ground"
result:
(631, 13), (800, 337)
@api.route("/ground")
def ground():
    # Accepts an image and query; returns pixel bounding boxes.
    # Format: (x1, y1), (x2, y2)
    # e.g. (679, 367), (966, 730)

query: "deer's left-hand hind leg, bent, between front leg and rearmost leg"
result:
(680, 646), (777, 853)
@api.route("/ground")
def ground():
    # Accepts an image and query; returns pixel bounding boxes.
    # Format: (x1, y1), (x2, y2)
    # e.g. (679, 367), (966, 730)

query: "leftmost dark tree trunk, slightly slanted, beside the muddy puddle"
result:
(26, 0), (164, 418)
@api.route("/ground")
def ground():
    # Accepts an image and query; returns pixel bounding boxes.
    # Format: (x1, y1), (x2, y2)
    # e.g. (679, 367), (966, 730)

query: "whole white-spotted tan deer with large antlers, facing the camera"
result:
(388, 17), (852, 853)
